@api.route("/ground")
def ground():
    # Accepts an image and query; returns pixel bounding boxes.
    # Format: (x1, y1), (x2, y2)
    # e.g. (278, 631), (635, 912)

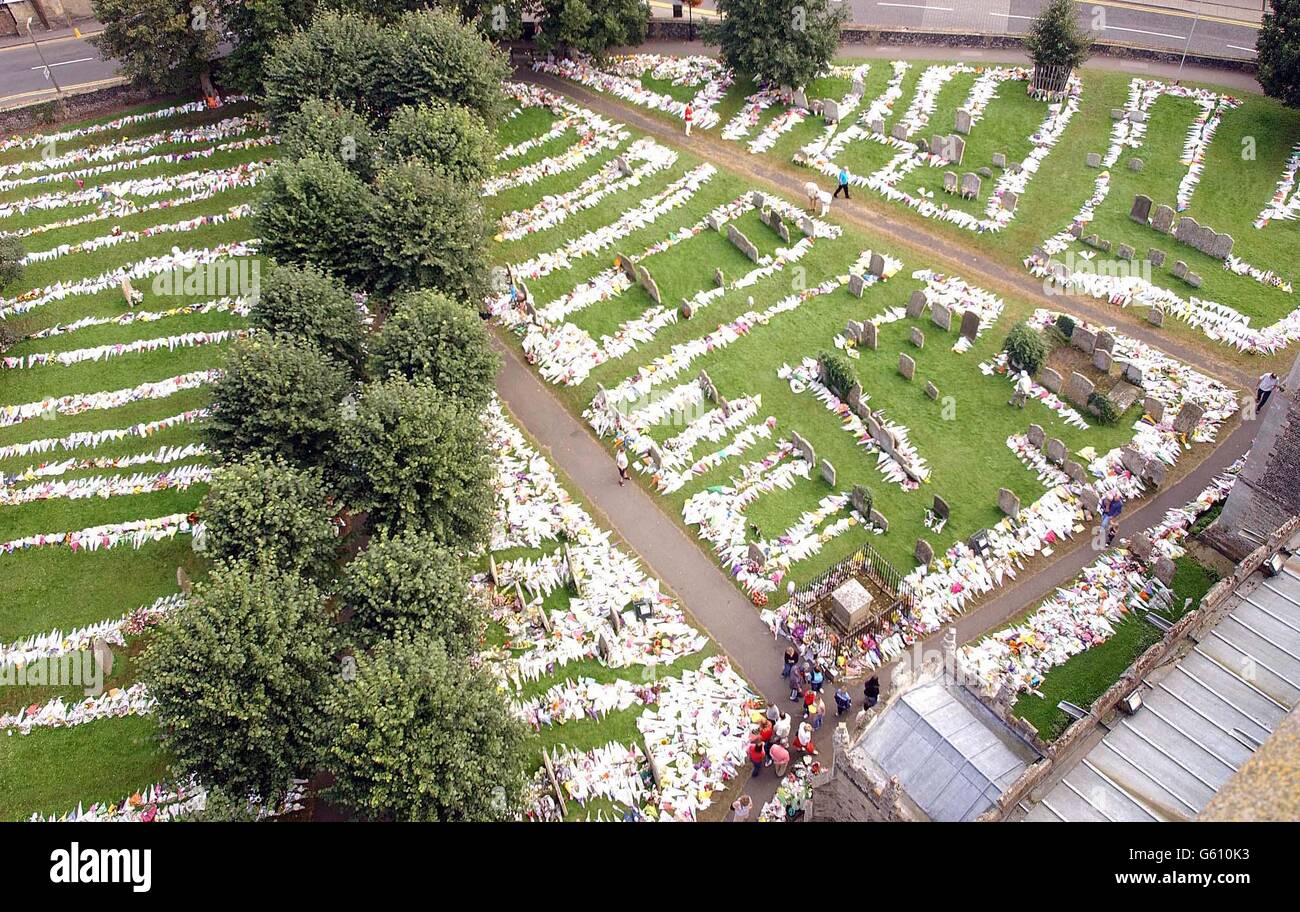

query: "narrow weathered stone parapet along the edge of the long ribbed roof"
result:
(980, 516), (1300, 821)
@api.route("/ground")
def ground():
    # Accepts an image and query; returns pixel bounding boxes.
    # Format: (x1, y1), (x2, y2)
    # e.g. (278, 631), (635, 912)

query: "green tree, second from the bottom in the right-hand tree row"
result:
(339, 531), (486, 659)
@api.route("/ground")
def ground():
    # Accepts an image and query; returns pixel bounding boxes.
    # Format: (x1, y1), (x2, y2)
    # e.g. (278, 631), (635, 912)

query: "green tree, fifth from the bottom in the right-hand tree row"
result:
(366, 160), (488, 301)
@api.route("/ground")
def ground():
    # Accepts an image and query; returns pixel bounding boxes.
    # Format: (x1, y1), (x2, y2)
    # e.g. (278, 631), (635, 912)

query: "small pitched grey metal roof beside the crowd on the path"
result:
(852, 682), (1036, 820)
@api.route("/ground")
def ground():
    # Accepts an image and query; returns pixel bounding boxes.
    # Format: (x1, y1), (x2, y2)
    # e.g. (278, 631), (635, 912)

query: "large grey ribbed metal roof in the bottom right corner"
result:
(1024, 557), (1300, 821)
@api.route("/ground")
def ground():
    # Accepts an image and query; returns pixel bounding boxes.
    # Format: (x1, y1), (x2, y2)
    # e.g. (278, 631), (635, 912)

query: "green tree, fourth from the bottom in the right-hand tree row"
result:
(372, 291), (501, 409)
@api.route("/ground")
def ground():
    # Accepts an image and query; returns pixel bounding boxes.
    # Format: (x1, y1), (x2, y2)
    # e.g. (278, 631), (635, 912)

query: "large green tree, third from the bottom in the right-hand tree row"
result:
(332, 377), (493, 548)
